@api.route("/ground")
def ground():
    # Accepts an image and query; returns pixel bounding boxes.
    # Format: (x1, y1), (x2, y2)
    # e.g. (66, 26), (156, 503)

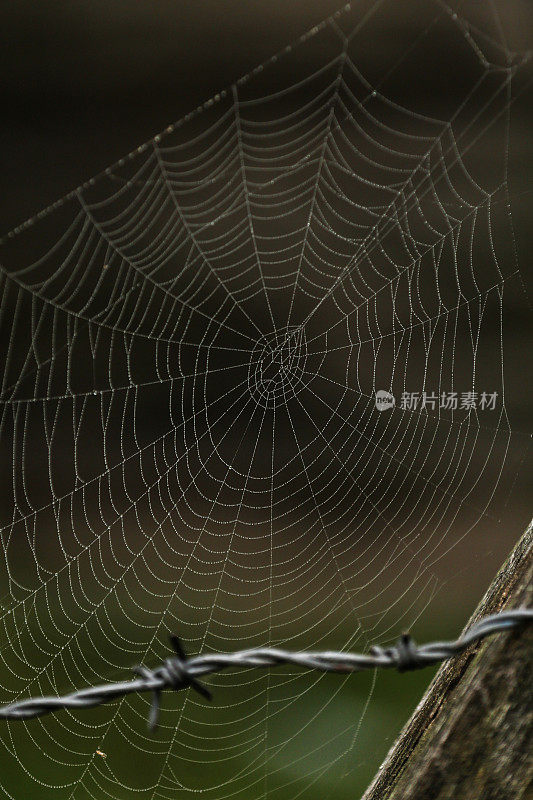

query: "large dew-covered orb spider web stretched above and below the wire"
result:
(0, 0), (528, 800)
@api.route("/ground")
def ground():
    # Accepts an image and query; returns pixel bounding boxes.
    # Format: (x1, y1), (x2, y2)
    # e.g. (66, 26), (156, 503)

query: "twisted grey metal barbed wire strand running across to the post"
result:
(0, 608), (533, 730)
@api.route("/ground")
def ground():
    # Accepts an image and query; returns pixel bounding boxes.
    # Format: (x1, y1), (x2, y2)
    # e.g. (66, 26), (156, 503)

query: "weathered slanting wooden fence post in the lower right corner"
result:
(362, 523), (533, 800)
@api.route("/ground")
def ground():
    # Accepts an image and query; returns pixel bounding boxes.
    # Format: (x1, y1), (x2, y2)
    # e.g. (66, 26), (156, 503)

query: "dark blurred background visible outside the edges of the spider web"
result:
(0, 0), (533, 800)
